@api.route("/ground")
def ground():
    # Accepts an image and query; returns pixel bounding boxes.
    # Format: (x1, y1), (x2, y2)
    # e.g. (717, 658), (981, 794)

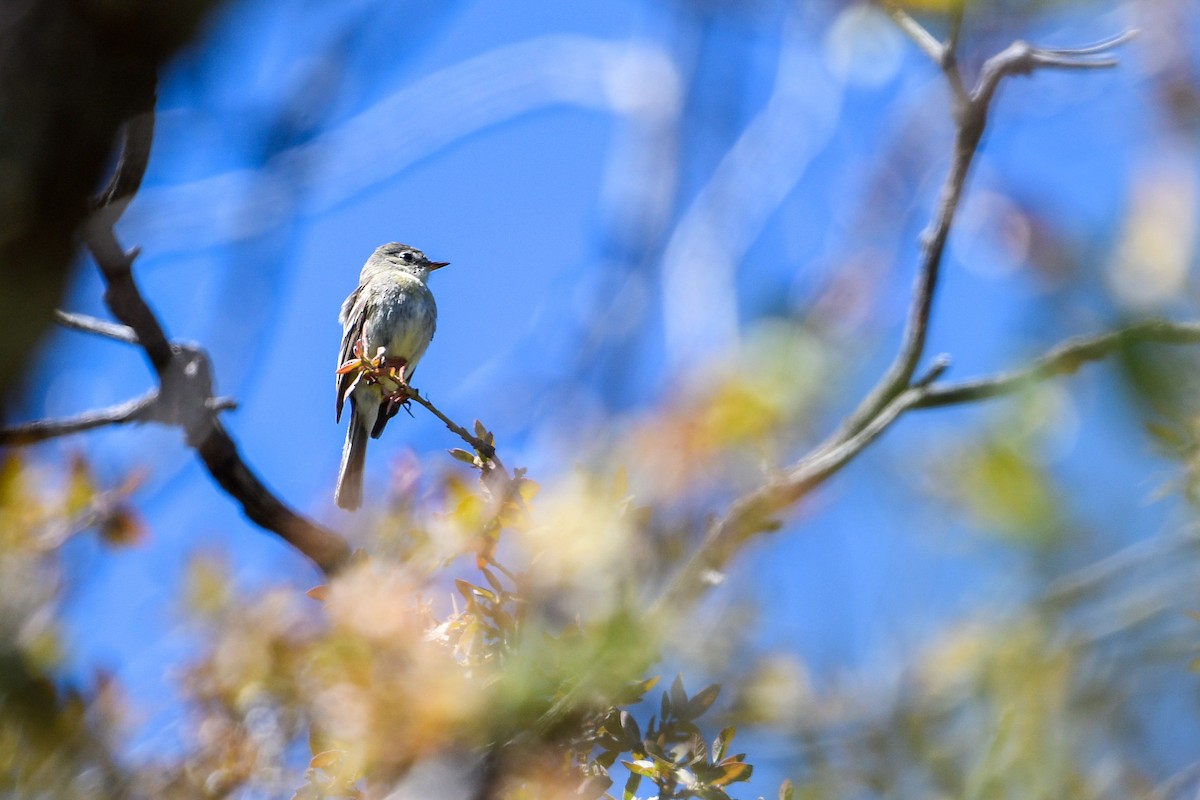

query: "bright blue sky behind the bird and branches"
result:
(16, 0), (1198, 793)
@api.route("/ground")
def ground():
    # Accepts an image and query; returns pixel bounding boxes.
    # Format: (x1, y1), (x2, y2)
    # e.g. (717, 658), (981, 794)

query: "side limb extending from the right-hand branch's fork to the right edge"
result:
(913, 319), (1200, 408)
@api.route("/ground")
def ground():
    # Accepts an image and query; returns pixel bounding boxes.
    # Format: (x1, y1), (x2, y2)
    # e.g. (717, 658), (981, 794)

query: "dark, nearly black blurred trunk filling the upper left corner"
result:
(0, 0), (217, 398)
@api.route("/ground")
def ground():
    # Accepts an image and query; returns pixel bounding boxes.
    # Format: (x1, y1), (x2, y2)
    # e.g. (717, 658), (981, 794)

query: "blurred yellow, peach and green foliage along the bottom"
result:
(7, 351), (1200, 800)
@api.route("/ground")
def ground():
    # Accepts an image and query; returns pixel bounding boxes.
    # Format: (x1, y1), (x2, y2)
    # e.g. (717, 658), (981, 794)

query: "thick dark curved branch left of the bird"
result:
(76, 107), (350, 575)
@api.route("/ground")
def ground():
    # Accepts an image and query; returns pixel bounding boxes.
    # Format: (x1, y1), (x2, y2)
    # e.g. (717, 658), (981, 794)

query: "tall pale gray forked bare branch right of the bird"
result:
(655, 25), (1132, 610)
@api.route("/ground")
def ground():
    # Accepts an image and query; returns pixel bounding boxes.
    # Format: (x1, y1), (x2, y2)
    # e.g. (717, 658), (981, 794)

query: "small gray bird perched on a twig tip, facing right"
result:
(334, 242), (449, 511)
